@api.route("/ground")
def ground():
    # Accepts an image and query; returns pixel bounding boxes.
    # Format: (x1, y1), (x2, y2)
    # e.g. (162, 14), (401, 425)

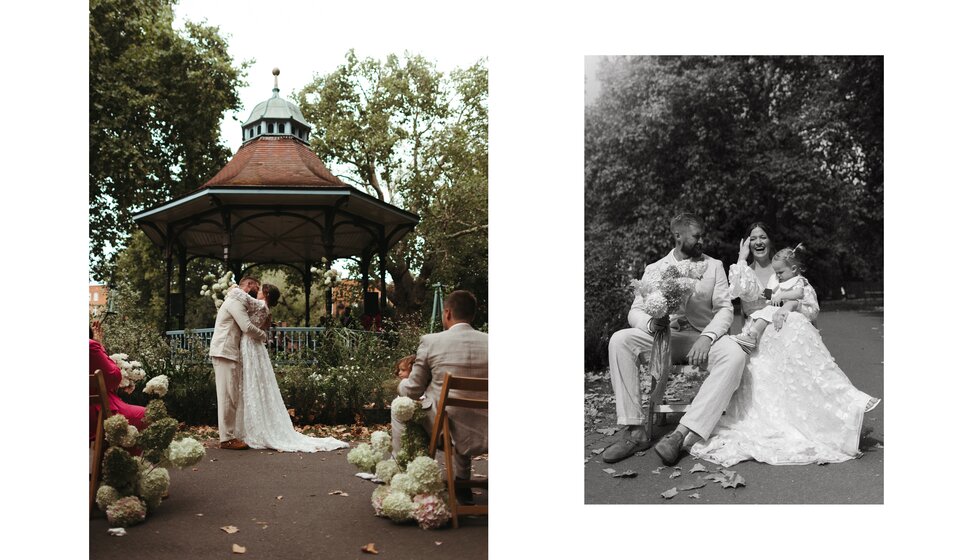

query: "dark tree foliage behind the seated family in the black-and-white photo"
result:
(585, 57), (883, 367)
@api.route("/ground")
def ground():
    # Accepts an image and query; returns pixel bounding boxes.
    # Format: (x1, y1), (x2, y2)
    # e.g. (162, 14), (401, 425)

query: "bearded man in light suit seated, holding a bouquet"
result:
(602, 214), (746, 466)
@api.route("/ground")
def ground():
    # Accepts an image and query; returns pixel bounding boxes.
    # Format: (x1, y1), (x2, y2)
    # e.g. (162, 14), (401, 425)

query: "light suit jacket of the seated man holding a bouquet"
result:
(629, 249), (735, 340)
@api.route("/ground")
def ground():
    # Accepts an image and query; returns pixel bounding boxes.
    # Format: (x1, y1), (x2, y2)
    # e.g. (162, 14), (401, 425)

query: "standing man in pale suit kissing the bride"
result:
(208, 276), (267, 449)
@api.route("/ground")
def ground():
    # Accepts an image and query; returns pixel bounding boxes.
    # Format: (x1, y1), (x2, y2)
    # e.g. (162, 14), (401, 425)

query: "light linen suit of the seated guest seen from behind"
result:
(391, 323), (489, 478)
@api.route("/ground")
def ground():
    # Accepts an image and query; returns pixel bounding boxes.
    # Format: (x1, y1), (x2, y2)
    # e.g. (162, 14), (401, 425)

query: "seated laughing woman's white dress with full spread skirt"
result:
(691, 265), (872, 467)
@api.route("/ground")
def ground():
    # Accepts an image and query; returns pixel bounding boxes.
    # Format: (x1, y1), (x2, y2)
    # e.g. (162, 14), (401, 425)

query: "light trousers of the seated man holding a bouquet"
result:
(609, 328), (746, 439)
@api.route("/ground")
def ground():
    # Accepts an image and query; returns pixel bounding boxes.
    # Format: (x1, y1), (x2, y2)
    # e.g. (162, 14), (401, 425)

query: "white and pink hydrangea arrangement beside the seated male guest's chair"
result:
(347, 397), (451, 529)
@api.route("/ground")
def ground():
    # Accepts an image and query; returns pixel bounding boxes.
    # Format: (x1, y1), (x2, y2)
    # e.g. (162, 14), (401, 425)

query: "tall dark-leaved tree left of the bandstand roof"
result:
(89, 0), (249, 279)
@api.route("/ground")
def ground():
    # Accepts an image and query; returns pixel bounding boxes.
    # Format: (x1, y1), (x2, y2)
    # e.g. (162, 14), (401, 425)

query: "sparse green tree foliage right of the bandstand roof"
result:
(296, 51), (488, 324)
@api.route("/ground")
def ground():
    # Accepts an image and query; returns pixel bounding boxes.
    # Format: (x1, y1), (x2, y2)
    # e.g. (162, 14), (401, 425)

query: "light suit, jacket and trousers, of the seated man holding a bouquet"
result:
(609, 250), (746, 439)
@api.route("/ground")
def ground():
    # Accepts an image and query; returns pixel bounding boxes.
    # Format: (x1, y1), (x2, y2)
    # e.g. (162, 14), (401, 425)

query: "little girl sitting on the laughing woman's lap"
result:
(734, 243), (817, 353)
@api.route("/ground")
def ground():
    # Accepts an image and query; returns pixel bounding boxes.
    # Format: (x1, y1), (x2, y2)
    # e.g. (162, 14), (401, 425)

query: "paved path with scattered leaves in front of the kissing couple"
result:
(89, 440), (488, 560)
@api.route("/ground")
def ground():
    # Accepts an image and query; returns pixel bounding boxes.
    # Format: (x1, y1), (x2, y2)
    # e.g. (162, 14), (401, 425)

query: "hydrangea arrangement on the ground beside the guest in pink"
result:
(95, 375), (204, 527)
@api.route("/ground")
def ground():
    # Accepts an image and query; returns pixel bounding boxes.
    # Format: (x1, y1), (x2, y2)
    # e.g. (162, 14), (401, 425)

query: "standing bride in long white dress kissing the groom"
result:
(227, 284), (349, 453)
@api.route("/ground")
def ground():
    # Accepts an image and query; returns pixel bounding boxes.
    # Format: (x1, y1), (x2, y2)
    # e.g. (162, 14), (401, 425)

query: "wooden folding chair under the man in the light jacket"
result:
(429, 373), (488, 529)
